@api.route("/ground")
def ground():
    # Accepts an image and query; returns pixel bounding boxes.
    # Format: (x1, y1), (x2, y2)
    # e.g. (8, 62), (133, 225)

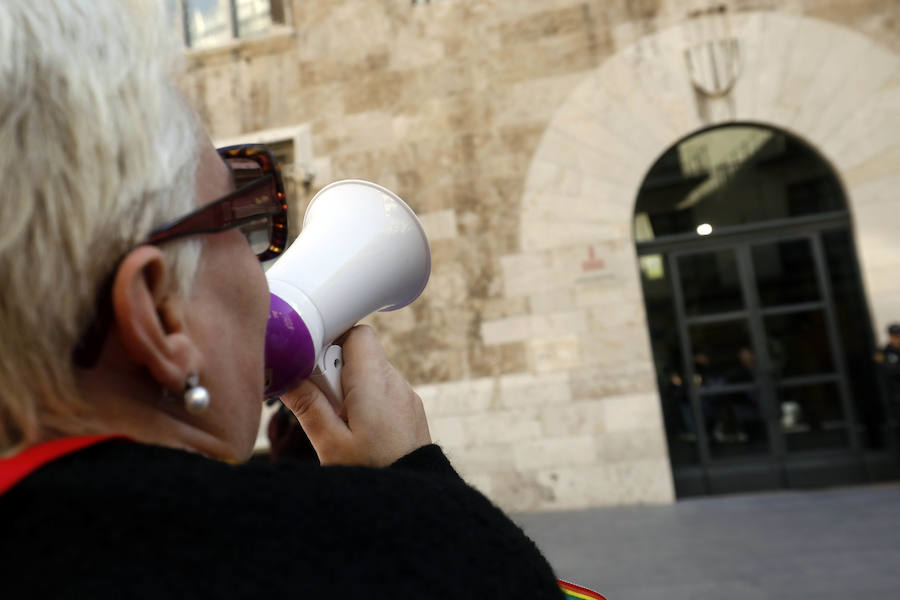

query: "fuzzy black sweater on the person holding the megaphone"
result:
(0, 440), (562, 600)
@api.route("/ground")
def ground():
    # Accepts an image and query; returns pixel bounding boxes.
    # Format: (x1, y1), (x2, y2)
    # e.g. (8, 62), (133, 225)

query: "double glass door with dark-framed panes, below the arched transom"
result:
(668, 234), (858, 493)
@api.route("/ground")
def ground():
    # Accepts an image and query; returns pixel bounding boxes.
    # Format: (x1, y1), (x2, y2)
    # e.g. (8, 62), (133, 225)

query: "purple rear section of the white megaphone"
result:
(266, 294), (316, 398)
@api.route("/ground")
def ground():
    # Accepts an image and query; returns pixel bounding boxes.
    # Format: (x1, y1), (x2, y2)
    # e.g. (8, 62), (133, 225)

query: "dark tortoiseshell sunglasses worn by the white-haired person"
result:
(72, 144), (288, 369)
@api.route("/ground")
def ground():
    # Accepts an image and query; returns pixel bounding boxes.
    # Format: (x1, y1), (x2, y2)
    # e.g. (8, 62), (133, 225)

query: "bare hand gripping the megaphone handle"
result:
(281, 325), (431, 467)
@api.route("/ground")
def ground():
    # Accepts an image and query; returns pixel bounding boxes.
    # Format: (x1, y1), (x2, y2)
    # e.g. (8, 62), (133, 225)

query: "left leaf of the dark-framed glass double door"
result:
(669, 245), (781, 493)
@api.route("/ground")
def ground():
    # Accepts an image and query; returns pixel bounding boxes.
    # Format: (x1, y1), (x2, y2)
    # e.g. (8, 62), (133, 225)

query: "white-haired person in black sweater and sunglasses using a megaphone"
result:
(0, 0), (561, 599)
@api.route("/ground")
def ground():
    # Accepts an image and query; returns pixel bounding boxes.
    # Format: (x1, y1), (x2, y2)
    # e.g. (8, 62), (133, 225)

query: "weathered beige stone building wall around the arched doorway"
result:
(178, 0), (900, 511)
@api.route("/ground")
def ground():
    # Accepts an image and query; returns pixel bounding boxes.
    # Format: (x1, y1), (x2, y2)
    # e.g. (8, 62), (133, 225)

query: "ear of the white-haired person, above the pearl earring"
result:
(112, 246), (200, 393)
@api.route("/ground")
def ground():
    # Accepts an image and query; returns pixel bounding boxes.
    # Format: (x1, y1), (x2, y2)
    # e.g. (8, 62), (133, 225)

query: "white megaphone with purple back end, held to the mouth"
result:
(265, 179), (431, 409)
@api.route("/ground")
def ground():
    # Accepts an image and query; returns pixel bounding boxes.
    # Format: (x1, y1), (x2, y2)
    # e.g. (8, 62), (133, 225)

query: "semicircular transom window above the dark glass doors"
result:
(634, 123), (847, 242)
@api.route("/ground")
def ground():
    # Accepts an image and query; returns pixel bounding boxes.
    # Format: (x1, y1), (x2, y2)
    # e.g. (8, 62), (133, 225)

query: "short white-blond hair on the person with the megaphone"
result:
(0, 0), (199, 453)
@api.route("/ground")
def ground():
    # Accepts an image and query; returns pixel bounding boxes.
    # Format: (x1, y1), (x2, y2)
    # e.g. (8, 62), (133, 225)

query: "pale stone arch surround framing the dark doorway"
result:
(502, 12), (900, 505)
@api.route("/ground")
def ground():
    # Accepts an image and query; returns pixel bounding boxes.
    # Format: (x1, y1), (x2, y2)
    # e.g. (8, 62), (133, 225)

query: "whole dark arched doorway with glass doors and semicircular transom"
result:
(634, 124), (891, 496)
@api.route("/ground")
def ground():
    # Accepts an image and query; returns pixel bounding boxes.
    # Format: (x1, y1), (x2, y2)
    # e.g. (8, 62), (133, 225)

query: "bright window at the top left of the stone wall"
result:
(169, 0), (285, 48)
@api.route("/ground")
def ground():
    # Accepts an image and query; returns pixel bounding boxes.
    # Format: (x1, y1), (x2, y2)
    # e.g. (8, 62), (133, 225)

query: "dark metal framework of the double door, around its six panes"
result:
(637, 211), (884, 493)
